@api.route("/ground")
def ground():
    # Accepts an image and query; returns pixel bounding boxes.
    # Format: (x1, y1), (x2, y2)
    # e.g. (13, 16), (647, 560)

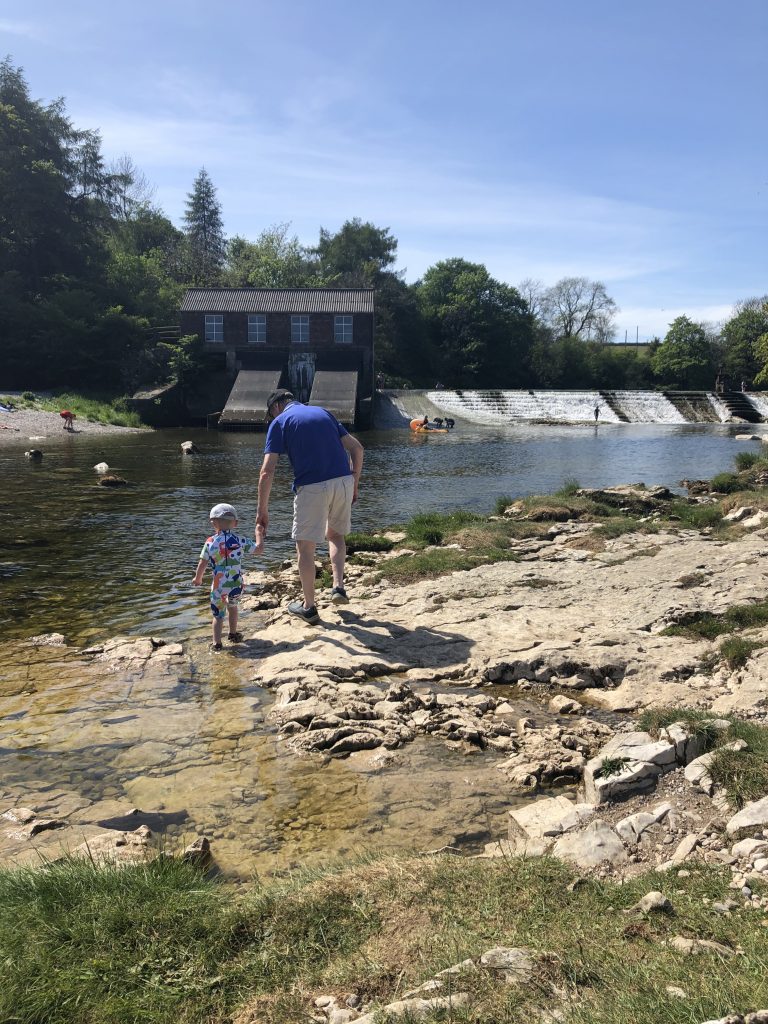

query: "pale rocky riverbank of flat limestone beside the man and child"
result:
(3, 479), (768, 881)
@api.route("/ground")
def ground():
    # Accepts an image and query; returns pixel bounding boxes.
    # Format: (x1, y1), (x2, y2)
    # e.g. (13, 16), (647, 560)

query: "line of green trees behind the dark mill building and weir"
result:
(0, 58), (768, 393)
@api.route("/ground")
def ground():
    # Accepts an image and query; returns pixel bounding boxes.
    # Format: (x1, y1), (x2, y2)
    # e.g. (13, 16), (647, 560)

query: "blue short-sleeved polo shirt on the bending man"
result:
(264, 401), (352, 490)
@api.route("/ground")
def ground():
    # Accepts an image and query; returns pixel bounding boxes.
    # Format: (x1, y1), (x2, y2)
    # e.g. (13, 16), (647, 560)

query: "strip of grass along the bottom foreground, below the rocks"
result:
(0, 856), (768, 1024)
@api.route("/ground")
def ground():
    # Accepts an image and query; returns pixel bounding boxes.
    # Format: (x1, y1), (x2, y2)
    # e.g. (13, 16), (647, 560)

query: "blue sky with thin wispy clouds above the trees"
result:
(0, 0), (768, 340)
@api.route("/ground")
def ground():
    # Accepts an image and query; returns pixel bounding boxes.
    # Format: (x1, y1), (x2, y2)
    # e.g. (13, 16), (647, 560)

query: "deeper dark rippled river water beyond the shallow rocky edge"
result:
(0, 424), (758, 642)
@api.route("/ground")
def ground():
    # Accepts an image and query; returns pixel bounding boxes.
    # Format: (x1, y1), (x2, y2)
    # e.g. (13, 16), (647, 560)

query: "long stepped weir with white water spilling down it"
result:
(375, 389), (768, 429)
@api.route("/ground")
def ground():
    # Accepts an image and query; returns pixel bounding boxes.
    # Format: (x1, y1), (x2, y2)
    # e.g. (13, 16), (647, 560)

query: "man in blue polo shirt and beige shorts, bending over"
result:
(256, 388), (364, 624)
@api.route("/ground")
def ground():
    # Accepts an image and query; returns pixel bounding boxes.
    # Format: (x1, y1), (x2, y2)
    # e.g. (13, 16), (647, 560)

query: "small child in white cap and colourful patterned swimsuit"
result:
(193, 502), (264, 650)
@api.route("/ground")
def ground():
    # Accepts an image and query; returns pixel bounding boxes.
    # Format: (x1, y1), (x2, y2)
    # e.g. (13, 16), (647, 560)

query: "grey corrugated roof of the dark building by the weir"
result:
(181, 288), (374, 313)
